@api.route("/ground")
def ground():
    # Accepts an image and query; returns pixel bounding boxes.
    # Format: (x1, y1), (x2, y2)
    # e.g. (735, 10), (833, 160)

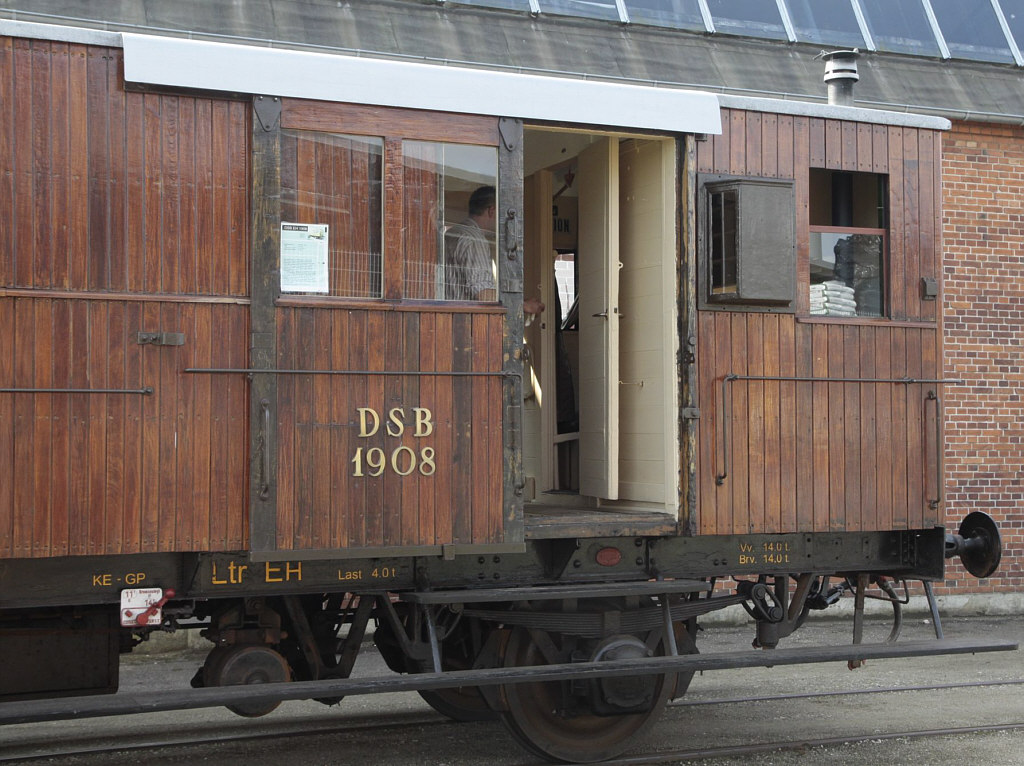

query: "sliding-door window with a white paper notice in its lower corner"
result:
(281, 130), (384, 298)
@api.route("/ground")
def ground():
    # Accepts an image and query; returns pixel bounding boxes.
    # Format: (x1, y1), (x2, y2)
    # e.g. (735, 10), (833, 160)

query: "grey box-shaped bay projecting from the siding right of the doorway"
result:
(698, 176), (796, 311)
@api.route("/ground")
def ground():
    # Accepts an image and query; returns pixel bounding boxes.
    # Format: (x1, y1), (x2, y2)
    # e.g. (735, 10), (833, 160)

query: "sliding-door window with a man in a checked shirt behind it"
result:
(402, 140), (499, 301)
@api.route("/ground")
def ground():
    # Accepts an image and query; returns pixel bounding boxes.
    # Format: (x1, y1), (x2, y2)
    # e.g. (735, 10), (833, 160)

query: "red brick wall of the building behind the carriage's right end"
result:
(942, 123), (1024, 592)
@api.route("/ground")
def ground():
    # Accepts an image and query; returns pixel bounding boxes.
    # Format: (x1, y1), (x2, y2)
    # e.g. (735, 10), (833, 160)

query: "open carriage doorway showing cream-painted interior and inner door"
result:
(523, 128), (679, 518)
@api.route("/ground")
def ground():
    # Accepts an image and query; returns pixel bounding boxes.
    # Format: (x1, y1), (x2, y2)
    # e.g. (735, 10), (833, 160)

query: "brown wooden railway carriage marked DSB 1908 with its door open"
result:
(0, 23), (998, 761)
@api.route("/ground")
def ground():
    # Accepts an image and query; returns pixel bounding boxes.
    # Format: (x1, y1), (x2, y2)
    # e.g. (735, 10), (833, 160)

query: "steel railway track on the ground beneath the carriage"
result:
(0, 679), (1024, 766)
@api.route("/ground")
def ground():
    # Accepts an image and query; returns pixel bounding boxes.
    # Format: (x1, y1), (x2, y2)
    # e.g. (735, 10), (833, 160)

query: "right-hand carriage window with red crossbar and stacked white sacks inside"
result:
(810, 168), (888, 316)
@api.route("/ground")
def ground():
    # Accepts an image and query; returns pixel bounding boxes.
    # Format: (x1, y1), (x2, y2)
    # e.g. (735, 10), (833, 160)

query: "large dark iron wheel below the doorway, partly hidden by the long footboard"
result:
(502, 628), (675, 763)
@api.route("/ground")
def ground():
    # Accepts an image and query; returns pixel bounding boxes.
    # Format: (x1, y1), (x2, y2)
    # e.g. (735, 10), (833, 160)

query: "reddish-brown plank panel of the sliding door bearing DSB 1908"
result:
(276, 306), (504, 550)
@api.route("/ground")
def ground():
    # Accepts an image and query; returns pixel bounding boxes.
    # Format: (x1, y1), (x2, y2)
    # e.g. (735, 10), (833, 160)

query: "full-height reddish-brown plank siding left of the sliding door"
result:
(0, 38), (249, 557)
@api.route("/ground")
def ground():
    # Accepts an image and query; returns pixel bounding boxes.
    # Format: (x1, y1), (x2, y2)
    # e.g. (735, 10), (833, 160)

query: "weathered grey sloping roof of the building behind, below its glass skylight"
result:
(8, 0), (1024, 124)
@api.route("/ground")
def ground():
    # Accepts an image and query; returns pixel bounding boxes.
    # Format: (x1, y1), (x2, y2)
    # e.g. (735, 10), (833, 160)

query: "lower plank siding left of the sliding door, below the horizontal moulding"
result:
(0, 297), (248, 558)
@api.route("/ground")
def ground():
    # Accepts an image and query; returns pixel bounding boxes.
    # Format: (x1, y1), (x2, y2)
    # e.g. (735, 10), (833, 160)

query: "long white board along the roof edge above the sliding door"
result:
(122, 34), (722, 133)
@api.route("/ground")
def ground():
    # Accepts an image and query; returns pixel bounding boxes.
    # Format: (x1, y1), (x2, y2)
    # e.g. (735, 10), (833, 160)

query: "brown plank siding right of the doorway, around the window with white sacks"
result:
(696, 110), (942, 534)
